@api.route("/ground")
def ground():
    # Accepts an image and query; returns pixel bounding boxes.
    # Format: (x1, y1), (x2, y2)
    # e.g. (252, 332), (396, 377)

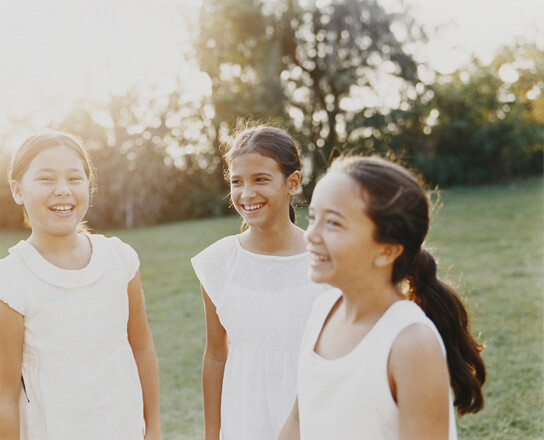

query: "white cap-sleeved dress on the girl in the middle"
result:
(191, 235), (327, 440)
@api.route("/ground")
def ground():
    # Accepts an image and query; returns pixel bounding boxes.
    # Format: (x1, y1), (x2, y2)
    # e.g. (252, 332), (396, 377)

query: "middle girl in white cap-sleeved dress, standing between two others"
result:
(192, 126), (325, 440)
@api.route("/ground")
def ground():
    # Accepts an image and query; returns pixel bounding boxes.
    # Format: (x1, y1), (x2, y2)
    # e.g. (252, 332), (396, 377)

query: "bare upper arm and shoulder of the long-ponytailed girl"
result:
(388, 324), (450, 440)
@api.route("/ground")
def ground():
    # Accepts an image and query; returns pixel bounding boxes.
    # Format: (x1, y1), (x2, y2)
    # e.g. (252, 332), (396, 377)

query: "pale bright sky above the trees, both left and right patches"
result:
(0, 0), (544, 148)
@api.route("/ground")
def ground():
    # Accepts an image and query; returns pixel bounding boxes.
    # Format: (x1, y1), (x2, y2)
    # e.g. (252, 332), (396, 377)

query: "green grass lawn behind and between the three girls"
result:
(0, 179), (544, 440)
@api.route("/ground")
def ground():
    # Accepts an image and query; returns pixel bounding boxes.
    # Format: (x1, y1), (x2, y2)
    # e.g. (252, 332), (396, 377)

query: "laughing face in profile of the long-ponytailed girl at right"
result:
(304, 171), (386, 290)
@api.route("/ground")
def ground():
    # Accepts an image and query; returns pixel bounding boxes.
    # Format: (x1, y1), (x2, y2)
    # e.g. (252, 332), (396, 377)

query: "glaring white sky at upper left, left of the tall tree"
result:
(0, 0), (207, 137)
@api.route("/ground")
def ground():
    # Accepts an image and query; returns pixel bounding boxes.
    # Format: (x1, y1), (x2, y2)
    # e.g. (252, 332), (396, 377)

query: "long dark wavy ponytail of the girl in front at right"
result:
(406, 249), (486, 414)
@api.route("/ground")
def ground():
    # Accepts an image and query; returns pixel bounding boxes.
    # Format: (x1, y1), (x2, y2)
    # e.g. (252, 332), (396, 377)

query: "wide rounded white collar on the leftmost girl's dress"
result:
(9, 235), (106, 288)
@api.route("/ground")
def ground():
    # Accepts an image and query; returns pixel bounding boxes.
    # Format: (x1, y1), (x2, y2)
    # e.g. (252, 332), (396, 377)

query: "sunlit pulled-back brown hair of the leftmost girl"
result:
(7, 132), (97, 230)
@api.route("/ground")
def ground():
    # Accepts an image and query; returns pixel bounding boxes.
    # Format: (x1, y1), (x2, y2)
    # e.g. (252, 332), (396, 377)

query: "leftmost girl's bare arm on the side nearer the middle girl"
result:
(128, 272), (161, 440)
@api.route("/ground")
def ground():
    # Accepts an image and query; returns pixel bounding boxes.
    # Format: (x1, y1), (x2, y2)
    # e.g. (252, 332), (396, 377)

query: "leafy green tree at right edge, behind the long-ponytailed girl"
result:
(415, 41), (544, 185)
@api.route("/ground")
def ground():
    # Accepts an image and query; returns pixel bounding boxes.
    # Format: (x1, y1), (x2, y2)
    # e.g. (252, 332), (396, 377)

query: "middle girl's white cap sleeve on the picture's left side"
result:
(191, 236), (237, 307)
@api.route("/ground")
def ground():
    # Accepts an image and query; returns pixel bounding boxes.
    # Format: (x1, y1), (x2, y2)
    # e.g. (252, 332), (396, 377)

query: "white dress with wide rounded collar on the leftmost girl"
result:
(0, 235), (144, 440)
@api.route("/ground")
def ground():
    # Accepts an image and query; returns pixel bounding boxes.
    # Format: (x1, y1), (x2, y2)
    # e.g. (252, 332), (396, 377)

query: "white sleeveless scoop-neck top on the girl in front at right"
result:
(298, 289), (457, 440)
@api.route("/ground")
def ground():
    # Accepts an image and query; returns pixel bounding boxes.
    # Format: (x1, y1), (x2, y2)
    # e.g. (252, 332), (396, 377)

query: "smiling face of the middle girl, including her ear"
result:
(230, 152), (300, 227)
